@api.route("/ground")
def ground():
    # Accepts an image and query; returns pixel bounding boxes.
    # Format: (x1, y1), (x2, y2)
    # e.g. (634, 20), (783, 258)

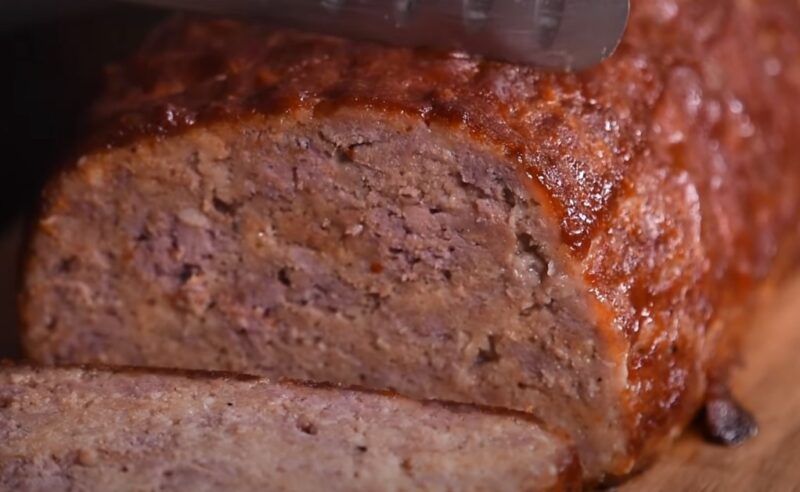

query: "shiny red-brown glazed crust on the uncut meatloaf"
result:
(72, 0), (800, 478)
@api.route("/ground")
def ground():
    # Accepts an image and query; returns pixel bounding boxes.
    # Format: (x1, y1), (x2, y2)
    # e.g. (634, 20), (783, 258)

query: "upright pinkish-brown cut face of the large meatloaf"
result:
(28, 111), (625, 480)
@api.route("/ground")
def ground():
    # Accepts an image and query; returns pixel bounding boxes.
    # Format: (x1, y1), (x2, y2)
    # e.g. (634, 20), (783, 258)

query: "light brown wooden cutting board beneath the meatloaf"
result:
(0, 227), (800, 492)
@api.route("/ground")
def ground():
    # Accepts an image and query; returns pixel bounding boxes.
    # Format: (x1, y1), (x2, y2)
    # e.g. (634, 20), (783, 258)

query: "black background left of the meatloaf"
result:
(0, 0), (165, 359)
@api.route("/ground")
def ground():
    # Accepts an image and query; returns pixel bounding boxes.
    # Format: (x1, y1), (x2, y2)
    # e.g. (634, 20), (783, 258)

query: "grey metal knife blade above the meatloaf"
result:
(125, 0), (630, 71)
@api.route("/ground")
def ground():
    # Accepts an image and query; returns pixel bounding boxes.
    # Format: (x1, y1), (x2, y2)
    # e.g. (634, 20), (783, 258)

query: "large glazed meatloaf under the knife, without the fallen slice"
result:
(17, 0), (800, 480)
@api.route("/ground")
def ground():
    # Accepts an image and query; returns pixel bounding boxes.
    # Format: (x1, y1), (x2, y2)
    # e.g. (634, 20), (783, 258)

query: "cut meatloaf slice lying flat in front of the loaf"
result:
(0, 368), (580, 492)
